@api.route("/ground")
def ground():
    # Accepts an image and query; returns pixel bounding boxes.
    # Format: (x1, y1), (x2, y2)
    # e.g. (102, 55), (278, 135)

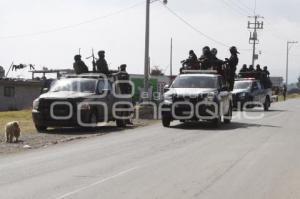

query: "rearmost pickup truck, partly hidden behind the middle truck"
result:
(232, 78), (272, 111)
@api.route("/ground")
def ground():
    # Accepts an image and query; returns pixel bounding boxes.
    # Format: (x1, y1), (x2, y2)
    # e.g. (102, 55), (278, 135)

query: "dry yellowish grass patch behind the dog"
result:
(0, 110), (36, 134)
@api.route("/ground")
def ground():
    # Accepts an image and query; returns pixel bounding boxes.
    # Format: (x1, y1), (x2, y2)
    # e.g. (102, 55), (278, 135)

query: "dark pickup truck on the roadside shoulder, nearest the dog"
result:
(32, 74), (131, 132)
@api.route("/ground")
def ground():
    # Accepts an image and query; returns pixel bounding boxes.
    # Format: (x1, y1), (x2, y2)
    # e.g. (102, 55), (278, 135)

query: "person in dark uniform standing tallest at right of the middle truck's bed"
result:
(226, 46), (240, 91)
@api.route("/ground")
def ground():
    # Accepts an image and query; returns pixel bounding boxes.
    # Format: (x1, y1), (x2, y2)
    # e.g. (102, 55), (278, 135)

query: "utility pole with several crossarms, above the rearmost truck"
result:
(248, 15), (264, 67)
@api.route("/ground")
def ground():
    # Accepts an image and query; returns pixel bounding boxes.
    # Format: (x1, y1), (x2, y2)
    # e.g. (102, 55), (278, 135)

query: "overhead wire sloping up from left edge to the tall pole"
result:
(0, 1), (144, 39)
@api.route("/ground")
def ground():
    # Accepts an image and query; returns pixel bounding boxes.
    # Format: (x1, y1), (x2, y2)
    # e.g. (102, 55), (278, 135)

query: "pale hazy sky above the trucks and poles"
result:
(0, 0), (300, 81)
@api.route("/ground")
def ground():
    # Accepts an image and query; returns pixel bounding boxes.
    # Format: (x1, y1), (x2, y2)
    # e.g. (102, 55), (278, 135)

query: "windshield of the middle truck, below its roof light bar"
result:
(172, 76), (218, 88)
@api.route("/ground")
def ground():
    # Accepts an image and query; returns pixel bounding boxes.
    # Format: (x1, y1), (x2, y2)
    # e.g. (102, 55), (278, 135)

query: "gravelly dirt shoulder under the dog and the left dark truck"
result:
(0, 118), (157, 156)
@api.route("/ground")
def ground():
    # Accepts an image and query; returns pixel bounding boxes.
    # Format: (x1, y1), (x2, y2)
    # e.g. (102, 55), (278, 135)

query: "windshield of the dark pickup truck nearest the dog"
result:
(50, 79), (97, 93)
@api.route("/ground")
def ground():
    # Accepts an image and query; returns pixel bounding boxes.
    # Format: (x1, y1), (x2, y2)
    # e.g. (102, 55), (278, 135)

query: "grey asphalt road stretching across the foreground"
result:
(0, 100), (300, 199)
